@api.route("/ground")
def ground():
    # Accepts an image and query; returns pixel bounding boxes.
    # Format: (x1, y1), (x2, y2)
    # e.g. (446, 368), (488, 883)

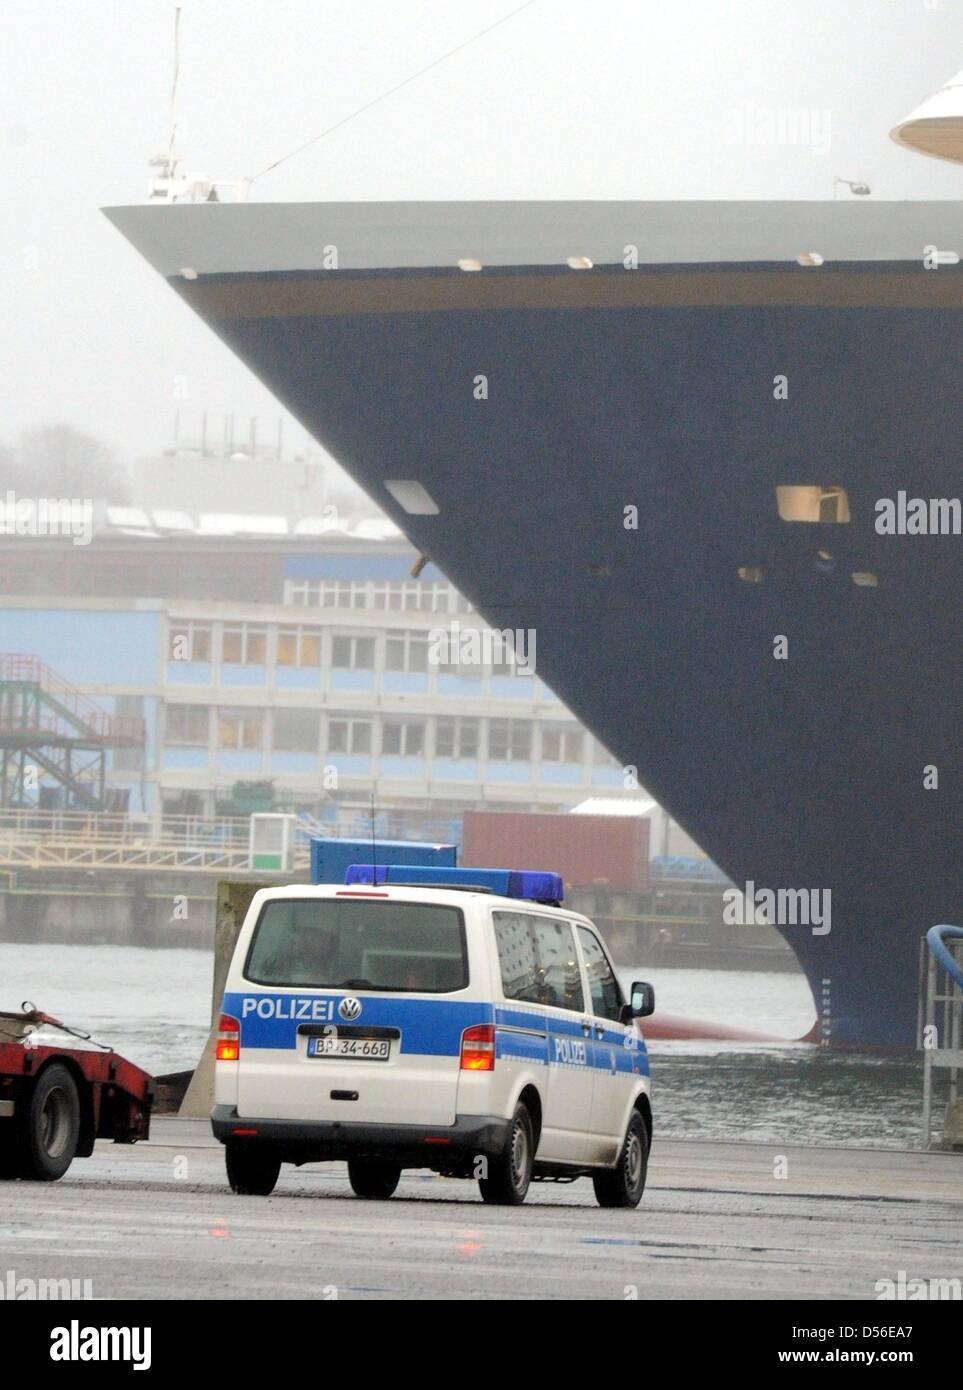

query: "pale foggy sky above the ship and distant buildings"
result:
(0, 0), (963, 469)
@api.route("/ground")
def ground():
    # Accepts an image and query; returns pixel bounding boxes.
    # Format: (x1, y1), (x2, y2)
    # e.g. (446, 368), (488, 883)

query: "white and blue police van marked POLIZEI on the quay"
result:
(213, 865), (655, 1207)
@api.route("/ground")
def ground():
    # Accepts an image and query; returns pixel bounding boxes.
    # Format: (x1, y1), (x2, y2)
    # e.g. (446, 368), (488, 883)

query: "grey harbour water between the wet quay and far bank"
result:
(0, 942), (923, 1148)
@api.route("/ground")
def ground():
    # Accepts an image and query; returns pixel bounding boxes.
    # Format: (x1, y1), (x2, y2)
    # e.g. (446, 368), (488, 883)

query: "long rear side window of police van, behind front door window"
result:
(492, 912), (585, 1012)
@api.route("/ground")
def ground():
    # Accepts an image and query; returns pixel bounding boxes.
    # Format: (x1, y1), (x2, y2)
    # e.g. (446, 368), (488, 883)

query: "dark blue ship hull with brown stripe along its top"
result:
(109, 210), (963, 1047)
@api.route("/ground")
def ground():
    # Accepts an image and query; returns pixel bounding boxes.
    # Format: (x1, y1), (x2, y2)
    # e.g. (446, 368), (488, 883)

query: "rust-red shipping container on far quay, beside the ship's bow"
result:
(461, 810), (649, 888)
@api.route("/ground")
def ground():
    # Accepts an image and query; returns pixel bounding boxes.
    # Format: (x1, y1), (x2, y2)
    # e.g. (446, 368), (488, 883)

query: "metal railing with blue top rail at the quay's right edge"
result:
(917, 924), (963, 1148)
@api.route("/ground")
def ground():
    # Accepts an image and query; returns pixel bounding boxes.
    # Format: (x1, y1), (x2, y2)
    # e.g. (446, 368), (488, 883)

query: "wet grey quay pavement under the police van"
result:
(0, 1118), (963, 1301)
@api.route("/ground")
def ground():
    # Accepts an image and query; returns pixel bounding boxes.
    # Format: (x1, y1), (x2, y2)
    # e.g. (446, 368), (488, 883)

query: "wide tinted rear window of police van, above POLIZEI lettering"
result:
(245, 898), (468, 994)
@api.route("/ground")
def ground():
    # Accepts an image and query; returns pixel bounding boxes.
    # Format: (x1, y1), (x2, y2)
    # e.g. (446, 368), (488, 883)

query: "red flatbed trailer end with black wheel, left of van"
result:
(0, 1005), (153, 1183)
